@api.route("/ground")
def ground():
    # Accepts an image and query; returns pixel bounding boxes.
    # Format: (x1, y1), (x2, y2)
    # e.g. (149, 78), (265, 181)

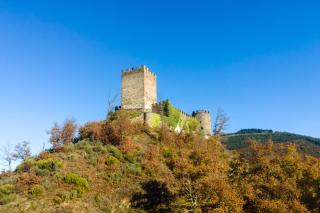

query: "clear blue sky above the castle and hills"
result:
(0, 0), (320, 159)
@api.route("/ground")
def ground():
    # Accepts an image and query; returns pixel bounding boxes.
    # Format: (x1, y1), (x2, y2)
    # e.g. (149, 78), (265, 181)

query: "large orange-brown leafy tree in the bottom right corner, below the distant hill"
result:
(229, 141), (312, 212)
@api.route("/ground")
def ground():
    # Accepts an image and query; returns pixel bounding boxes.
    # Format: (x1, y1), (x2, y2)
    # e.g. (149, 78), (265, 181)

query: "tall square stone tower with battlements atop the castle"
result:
(121, 66), (157, 112)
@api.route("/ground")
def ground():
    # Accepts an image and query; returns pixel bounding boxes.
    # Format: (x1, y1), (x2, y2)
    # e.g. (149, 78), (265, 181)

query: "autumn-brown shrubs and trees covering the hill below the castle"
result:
(0, 111), (320, 212)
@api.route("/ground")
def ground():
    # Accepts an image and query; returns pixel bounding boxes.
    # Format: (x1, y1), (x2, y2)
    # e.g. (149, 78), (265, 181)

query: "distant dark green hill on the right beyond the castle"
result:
(222, 129), (320, 157)
